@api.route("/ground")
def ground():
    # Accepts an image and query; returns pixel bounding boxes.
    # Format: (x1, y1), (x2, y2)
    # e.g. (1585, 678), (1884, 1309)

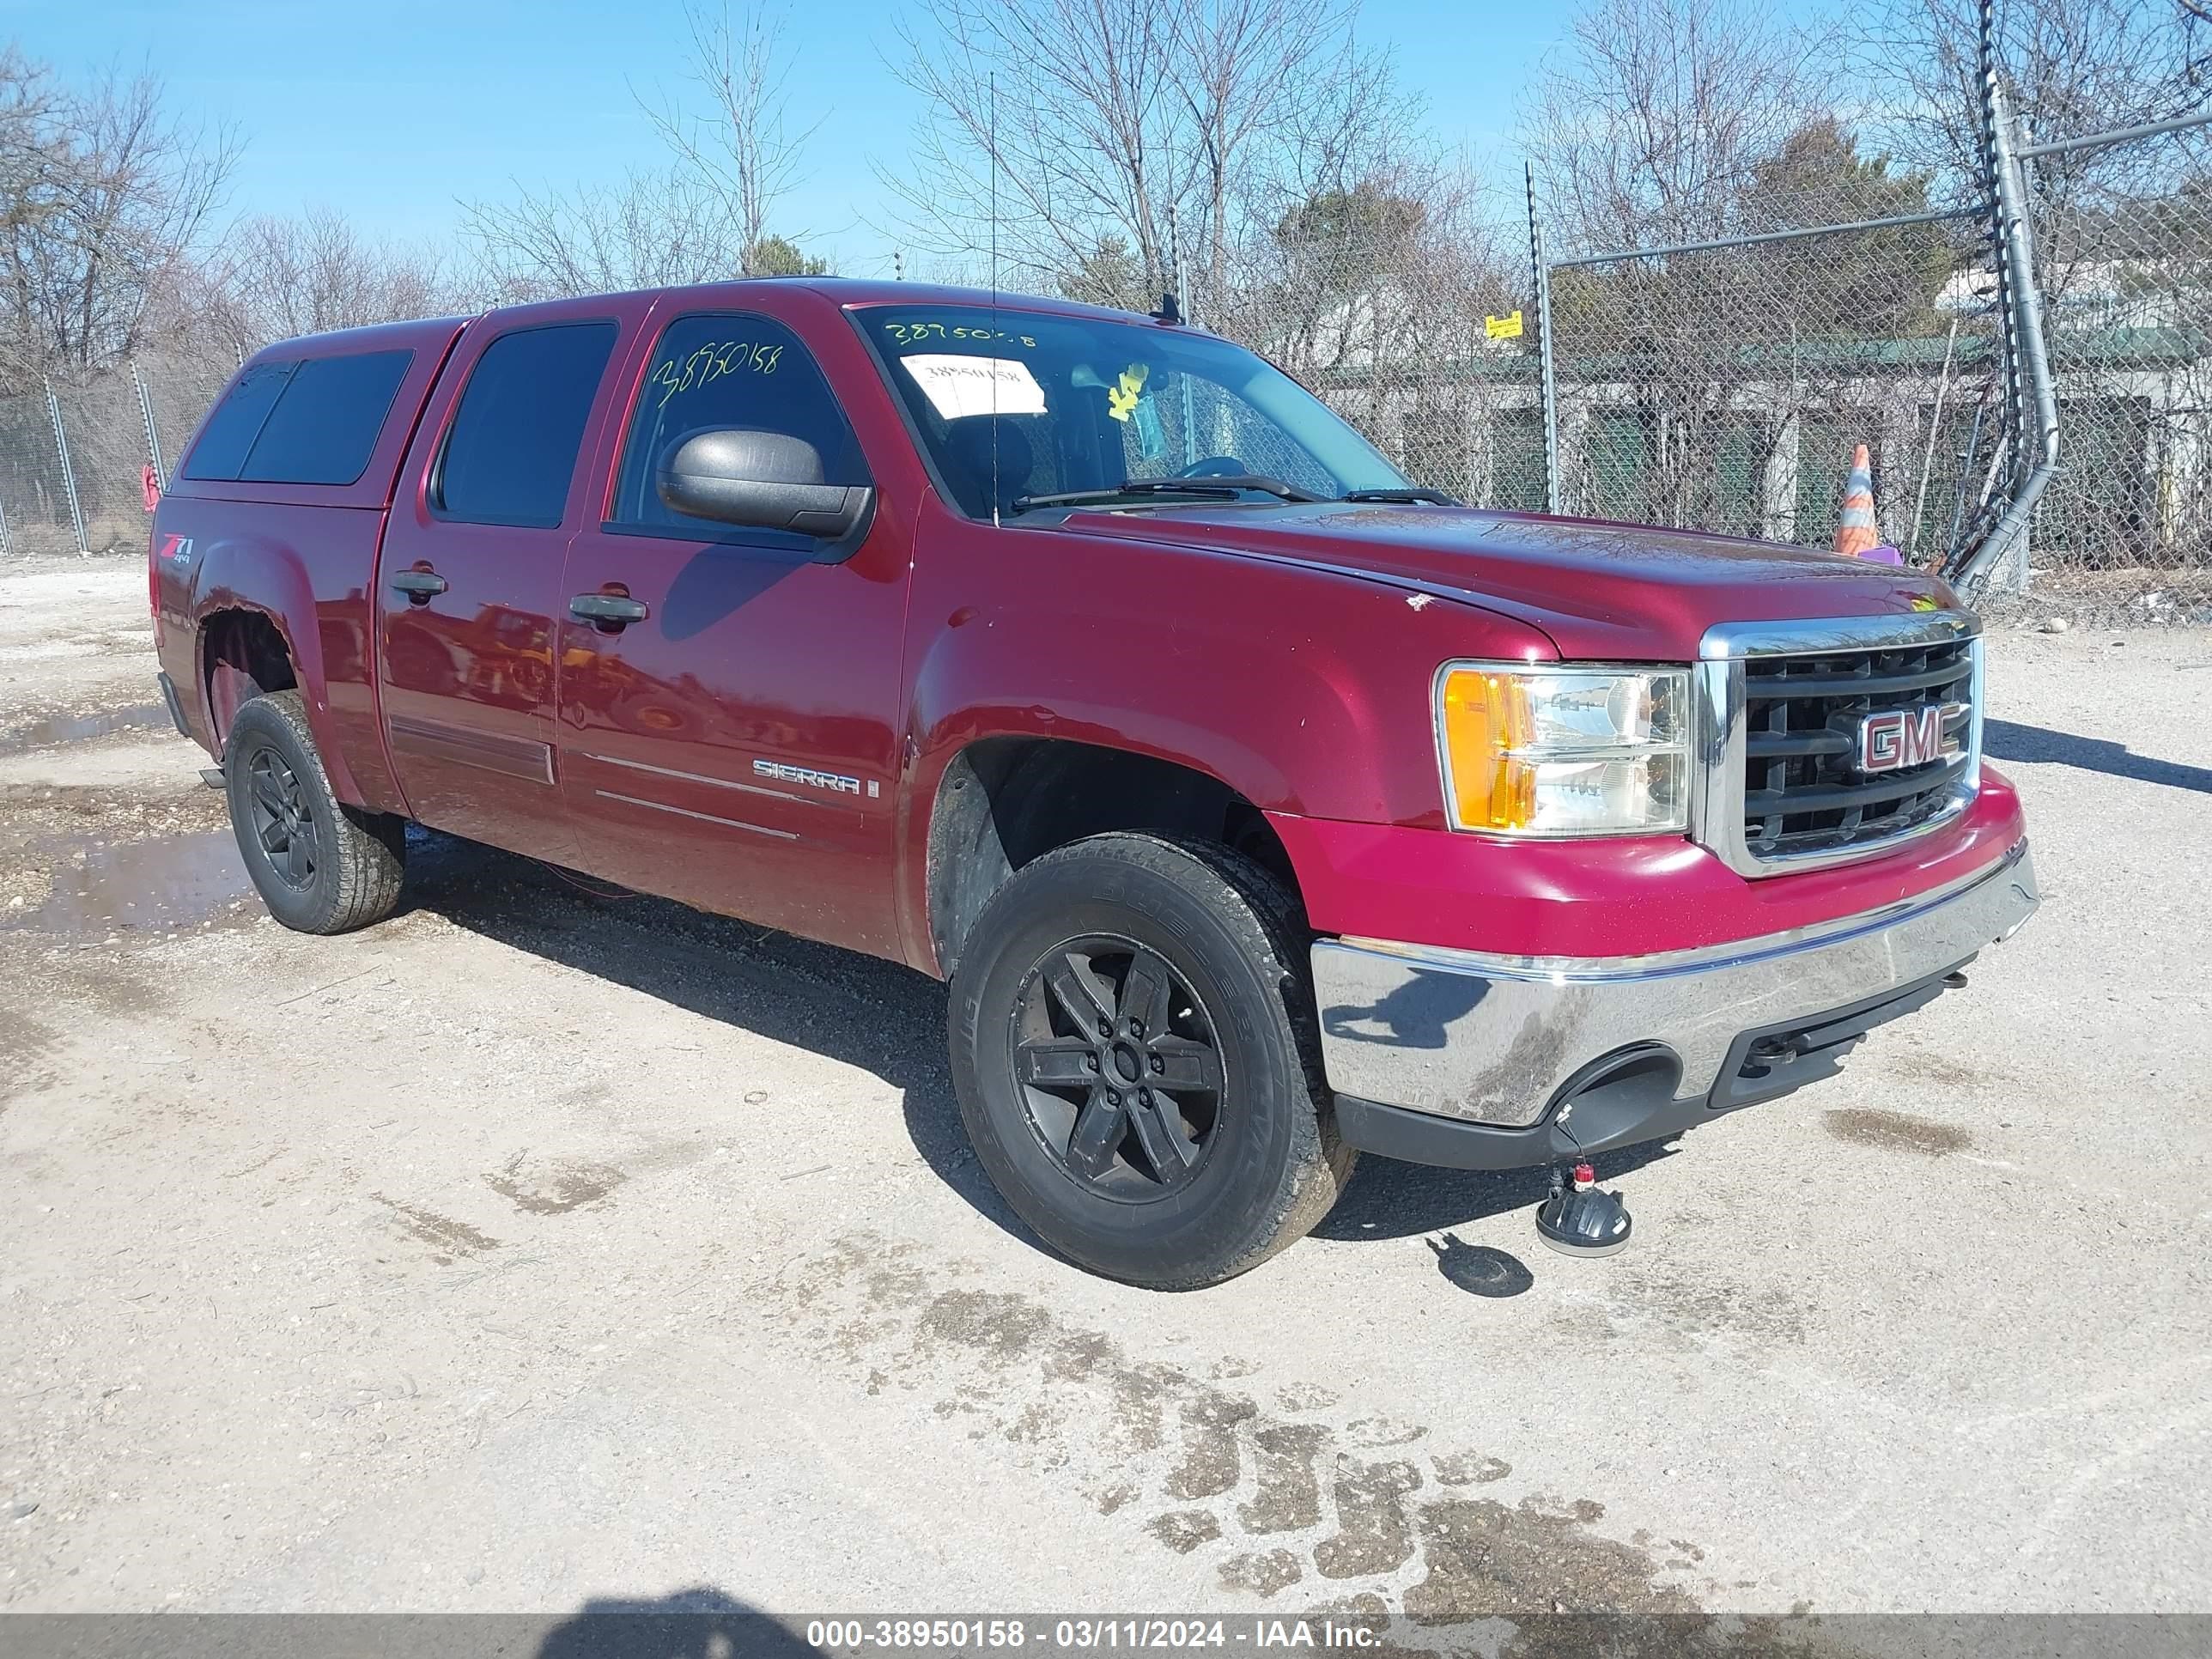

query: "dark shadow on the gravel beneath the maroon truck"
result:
(403, 834), (1663, 1249)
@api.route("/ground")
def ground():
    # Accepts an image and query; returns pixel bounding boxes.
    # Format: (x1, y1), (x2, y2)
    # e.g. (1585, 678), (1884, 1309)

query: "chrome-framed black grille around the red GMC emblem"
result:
(1697, 613), (1982, 876)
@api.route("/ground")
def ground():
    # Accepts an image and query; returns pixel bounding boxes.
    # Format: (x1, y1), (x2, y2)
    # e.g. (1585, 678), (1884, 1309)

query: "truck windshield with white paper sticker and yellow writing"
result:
(856, 305), (1409, 518)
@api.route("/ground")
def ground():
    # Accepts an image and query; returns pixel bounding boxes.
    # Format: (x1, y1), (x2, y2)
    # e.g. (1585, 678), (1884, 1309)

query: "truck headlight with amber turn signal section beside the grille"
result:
(1436, 661), (1690, 836)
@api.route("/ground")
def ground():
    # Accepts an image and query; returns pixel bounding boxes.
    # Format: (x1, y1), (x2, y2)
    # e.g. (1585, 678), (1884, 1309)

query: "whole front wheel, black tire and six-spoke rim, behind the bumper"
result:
(951, 834), (1354, 1290)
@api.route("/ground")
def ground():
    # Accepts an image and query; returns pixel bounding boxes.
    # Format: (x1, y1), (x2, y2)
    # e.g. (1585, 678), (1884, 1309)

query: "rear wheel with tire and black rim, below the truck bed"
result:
(223, 690), (407, 933)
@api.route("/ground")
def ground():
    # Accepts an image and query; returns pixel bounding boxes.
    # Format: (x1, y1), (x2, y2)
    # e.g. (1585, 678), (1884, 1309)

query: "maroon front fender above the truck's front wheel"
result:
(900, 525), (1555, 960)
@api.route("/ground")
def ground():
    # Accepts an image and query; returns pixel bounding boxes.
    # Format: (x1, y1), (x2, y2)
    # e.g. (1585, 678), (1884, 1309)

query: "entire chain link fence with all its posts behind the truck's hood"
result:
(1203, 55), (2212, 623)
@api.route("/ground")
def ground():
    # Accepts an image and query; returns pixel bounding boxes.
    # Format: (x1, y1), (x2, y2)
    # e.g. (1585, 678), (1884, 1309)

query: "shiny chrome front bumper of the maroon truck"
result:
(1314, 841), (2037, 1128)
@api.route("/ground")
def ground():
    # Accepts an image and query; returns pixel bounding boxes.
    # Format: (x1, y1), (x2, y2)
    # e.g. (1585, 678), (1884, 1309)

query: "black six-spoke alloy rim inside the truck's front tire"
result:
(1011, 933), (1225, 1203)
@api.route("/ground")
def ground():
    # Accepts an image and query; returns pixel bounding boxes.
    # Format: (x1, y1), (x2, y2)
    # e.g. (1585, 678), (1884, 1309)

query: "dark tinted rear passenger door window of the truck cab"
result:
(431, 323), (617, 529)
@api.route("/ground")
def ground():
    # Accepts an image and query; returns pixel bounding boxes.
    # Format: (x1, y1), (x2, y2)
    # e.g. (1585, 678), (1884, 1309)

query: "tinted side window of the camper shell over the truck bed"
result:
(184, 352), (414, 484)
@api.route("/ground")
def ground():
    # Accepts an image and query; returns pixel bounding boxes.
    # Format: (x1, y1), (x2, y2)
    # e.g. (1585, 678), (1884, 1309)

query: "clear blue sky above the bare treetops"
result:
(0, 0), (1566, 274)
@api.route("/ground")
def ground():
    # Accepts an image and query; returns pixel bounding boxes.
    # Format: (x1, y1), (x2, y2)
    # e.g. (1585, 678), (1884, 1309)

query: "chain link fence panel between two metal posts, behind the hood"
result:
(1551, 209), (2002, 564)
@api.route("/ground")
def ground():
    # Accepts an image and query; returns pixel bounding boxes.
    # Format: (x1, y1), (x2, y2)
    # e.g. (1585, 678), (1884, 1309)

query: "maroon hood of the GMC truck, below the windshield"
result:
(1064, 502), (1962, 661)
